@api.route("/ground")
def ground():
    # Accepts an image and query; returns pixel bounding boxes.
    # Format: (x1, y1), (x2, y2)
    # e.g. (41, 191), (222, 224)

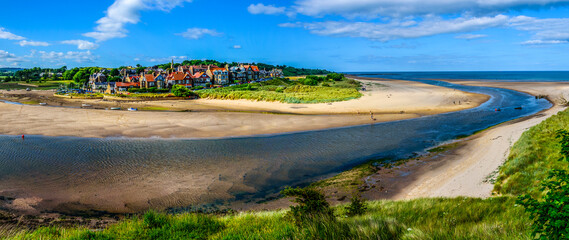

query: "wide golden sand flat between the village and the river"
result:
(0, 80), (488, 138)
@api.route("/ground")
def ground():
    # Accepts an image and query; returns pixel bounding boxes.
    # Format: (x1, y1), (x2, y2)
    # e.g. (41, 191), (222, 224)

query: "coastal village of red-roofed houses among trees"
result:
(88, 61), (284, 94)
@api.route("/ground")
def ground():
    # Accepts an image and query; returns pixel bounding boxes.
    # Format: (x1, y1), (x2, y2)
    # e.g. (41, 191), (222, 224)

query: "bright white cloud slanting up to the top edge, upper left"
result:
(83, 0), (191, 42)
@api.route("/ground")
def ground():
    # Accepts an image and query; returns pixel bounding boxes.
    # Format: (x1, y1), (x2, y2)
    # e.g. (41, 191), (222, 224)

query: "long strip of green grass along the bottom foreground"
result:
(5, 197), (530, 239)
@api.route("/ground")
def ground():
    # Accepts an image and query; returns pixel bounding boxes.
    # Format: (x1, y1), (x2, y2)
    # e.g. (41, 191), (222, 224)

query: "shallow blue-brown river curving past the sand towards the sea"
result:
(0, 80), (551, 213)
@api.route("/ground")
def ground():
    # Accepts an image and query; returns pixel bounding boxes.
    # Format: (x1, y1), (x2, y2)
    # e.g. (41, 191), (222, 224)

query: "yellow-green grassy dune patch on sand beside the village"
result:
(196, 79), (362, 103)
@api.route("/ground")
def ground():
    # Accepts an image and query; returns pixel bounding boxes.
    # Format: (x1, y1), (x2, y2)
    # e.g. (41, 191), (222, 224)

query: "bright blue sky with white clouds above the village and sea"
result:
(0, 0), (569, 71)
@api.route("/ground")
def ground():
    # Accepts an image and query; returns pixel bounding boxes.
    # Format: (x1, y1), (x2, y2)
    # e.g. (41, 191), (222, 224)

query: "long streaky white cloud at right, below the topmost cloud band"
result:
(280, 15), (508, 41)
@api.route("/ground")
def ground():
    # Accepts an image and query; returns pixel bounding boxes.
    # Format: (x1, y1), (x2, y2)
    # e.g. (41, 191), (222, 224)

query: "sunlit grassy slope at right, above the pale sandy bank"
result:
(494, 110), (569, 197)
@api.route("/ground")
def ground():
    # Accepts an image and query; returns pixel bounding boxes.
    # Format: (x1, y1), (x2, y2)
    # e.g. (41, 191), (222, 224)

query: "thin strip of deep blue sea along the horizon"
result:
(347, 71), (569, 82)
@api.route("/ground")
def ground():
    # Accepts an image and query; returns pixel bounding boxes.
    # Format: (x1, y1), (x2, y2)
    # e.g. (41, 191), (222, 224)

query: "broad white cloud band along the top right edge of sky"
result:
(292, 0), (569, 18)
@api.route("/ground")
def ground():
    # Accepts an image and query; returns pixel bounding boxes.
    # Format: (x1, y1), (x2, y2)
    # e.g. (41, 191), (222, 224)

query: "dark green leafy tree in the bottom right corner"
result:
(517, 130), (569, 239)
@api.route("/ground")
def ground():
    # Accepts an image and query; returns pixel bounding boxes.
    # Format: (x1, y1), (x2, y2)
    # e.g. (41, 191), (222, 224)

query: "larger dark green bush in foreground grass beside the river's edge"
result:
(281, 188), (334, 225)
